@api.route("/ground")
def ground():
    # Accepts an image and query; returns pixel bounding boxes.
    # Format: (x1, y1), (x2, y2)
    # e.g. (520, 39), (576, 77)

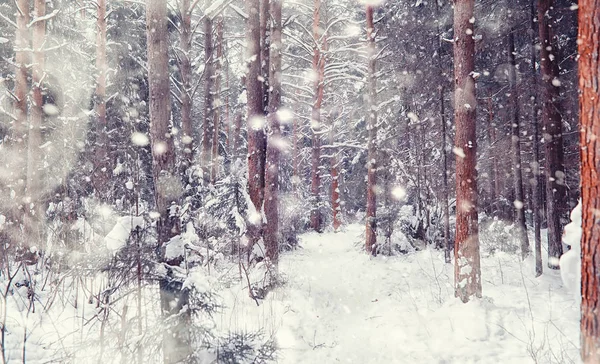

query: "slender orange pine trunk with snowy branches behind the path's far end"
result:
(310, 0), (325, 232)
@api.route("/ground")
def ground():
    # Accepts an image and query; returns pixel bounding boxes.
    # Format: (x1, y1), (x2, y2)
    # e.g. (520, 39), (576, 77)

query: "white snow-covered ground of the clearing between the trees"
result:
(217, 225), (579, 363)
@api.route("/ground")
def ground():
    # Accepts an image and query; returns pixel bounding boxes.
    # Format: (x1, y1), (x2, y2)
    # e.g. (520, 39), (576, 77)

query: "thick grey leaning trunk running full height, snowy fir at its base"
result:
(146, 0), (191, 364)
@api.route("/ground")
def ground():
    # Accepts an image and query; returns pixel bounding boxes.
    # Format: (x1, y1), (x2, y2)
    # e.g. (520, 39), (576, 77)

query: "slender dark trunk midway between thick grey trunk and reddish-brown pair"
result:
(202, 14), (215, 183)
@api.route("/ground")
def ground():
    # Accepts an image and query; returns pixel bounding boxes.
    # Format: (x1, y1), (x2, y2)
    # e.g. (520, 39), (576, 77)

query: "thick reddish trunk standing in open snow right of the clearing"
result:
(454, 0), (481, 302)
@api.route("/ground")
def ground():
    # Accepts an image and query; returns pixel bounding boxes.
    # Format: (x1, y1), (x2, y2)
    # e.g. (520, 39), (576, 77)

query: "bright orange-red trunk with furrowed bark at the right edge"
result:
(578, 0), (600, 364)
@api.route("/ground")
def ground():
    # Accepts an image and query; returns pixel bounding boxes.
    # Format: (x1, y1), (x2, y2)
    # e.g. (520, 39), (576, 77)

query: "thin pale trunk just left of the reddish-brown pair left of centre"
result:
(211, 16), (223, 183)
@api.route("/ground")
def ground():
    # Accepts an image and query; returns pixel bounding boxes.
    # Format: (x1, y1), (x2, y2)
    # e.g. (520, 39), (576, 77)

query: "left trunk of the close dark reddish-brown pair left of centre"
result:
(245, 0), (266, 212)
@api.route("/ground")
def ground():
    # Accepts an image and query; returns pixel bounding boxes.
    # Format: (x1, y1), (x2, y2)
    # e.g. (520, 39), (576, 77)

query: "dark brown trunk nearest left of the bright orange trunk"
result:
(538, 0), (567, 269)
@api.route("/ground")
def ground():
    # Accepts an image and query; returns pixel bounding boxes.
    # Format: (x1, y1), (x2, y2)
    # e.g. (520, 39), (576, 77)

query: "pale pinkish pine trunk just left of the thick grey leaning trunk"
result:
(94, 0), (110, 199)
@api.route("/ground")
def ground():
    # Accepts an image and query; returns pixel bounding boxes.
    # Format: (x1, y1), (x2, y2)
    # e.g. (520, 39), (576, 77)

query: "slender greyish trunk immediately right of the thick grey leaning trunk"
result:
(179, 0), (196, 169)
